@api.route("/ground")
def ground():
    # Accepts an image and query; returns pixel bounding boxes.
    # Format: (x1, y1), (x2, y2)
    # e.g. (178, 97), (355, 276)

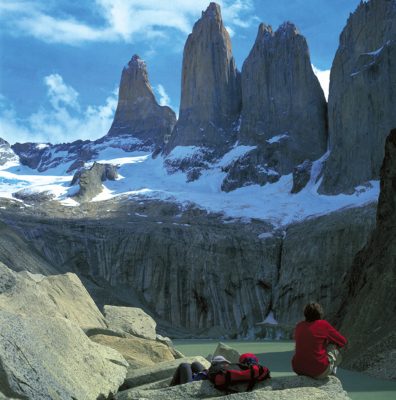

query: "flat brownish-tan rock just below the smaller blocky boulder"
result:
(90, 335), (175, 368)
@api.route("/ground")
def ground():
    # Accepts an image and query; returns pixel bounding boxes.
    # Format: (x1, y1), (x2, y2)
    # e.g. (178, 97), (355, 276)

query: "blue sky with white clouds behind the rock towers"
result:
(0, 0), (359, 143)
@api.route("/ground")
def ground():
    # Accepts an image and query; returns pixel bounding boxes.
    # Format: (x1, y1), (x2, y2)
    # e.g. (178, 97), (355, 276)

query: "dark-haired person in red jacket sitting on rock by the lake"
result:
(292, 303), (347, 379)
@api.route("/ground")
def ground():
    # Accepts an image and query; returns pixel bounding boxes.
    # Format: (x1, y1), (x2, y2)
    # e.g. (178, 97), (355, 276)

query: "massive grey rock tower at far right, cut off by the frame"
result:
(320, 0), (396, 194)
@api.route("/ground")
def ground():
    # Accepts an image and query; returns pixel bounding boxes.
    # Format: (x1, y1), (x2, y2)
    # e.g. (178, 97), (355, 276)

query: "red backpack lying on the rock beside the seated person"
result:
(208, 353), (270, 392)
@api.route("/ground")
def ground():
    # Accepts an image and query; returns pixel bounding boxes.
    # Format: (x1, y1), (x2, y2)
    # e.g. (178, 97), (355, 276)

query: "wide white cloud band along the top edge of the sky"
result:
(0, 0), (255, 44)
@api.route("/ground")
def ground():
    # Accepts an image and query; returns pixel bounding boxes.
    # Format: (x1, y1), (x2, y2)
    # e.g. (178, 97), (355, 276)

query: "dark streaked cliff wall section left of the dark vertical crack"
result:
(10, 211), (279, 336)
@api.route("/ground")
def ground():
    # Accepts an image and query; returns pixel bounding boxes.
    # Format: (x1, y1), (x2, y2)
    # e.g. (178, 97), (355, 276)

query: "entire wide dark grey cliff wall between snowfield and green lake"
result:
(0, 196), (375, 337)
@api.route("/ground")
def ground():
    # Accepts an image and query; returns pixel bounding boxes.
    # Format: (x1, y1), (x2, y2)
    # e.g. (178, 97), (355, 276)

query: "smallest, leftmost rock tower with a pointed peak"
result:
(108, 55), (176, 146)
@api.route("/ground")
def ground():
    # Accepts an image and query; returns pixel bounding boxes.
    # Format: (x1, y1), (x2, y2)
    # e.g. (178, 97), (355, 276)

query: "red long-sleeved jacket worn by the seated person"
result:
(292, 319), (347, 377)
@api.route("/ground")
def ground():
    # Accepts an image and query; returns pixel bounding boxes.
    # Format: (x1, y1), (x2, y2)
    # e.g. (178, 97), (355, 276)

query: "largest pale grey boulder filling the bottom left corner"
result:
(0, 311), (127, 400)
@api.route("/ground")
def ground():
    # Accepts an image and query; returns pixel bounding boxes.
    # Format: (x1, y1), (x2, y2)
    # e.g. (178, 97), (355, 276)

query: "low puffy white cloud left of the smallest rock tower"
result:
(0, 74), (118, 143)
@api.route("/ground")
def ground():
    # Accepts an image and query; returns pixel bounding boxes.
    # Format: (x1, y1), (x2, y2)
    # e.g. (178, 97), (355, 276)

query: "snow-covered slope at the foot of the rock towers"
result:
(0, 143), (379, 226)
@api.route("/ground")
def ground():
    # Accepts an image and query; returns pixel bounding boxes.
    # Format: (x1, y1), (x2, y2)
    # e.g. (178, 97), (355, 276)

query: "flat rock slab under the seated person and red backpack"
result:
(116, 376), (349, 400)
